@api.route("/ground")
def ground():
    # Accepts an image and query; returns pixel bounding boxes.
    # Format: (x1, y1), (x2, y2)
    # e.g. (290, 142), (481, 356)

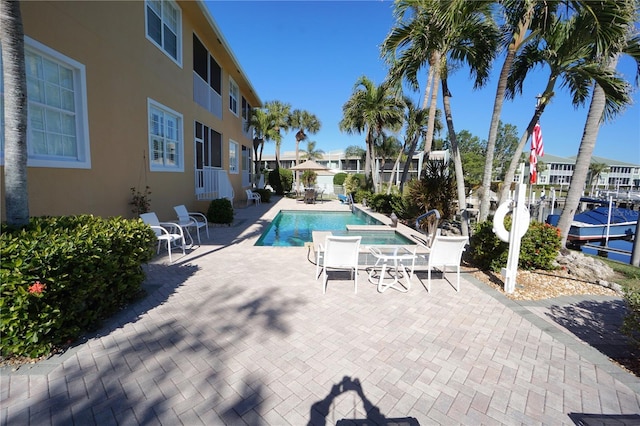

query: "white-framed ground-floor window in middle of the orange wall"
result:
(147, 99), (184, 172)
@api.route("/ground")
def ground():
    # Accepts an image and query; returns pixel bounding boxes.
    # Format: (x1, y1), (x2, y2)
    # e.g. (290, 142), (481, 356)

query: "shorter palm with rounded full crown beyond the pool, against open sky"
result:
(339, 76), (402, 188)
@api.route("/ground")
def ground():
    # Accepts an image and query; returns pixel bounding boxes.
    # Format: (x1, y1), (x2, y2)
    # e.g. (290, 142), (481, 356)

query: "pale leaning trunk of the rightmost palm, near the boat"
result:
(558, 56), (618, 247)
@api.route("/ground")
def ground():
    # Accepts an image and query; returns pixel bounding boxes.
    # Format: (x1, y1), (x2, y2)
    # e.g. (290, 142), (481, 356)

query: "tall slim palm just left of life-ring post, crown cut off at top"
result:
(478, 0), (558, 222)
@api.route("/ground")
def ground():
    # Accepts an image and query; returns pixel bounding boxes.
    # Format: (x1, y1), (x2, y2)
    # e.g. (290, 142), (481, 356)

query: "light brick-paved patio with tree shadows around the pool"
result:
(0, 200), (640, 425)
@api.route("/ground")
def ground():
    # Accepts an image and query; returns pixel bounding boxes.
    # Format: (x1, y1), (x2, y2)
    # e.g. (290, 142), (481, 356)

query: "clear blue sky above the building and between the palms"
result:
(206, 1), (640, 164)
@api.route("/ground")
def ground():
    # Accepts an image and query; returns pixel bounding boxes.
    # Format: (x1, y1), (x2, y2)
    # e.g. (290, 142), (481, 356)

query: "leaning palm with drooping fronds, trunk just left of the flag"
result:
(500, 4), (624, 206)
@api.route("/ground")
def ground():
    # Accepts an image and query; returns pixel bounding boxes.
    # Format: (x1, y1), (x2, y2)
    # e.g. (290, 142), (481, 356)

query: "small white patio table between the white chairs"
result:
(369, 246), (417, 293)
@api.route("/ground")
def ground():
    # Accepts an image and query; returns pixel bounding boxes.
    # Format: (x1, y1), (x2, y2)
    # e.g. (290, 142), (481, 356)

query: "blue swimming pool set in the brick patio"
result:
(255, 209), (415, 247)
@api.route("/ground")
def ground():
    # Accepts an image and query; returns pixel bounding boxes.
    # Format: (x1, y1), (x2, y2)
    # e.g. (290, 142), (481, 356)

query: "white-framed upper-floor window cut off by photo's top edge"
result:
(145, 0), (182, 66)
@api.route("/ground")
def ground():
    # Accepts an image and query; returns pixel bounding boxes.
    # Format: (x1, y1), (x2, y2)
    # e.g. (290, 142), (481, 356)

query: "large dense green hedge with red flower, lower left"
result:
(0, 215), (156, 357)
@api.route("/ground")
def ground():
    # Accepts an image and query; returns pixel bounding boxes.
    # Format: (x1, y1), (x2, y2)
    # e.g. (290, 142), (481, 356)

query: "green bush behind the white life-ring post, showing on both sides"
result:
(469, 217), (560, 272)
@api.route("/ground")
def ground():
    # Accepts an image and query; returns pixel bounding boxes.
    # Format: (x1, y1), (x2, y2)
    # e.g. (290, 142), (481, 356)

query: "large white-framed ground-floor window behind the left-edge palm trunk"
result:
(0, 37), (91, 169)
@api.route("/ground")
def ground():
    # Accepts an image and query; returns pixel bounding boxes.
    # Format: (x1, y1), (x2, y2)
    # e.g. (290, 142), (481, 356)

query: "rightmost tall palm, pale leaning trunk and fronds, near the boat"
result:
(558, 0), (640, 247)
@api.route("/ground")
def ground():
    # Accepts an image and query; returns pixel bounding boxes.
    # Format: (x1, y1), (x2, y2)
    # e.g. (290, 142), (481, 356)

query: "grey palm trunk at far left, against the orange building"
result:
(0, 0), (29, 226)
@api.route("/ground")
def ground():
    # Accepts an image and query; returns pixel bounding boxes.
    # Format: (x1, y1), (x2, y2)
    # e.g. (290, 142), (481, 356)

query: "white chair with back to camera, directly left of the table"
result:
(316, 235), (362, 294)
